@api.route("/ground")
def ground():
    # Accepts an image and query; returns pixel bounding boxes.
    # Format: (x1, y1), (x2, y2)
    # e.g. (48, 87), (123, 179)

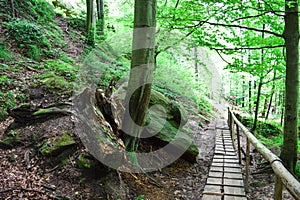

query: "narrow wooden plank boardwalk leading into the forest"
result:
(202, 120), (247, 200)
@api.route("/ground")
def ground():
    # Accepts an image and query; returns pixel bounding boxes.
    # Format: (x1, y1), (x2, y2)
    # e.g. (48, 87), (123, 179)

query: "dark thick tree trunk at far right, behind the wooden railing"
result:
(281, 0), (299, 173)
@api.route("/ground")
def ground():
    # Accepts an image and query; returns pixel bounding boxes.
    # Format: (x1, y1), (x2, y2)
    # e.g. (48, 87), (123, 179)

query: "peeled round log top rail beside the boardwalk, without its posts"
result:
(228, 108), (300, 199)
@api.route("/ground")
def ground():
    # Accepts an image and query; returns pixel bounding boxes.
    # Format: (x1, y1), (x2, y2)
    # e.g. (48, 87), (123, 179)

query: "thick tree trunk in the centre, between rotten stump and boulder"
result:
(122, 0), (156, 152)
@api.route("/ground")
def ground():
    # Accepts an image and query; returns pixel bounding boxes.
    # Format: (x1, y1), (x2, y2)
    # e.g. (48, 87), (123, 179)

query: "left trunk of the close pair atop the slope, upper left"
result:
(86, 0), (96, 46)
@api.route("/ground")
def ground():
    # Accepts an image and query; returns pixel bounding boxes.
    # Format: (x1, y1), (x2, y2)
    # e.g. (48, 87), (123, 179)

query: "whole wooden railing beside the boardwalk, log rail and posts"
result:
(228, 108), (300, 200)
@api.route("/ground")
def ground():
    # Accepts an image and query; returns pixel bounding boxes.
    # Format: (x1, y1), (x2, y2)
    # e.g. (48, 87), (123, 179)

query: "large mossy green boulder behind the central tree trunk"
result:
(113, 85), (199, 162)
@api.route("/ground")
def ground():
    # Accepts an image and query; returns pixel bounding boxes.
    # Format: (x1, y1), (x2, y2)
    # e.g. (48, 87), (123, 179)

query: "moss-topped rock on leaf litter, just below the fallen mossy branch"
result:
(40, 131), (76, 156)
